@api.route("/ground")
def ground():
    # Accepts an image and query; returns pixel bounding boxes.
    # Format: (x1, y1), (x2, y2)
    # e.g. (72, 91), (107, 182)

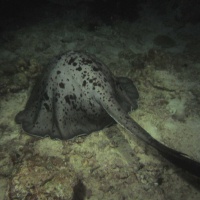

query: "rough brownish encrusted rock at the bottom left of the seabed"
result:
(9, 156), (79, 200)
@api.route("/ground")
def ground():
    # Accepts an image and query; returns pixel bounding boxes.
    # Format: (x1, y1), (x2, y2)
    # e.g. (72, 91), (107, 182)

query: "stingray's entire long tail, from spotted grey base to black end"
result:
(102, 97), (200, 178)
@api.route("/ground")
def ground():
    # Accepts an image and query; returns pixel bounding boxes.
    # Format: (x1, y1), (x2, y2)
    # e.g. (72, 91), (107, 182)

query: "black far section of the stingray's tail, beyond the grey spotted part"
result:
(149, 138), (200, 177)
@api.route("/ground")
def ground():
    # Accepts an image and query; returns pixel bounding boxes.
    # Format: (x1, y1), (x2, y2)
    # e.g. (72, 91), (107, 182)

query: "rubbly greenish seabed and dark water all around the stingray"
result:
(0, 0), (200, 200)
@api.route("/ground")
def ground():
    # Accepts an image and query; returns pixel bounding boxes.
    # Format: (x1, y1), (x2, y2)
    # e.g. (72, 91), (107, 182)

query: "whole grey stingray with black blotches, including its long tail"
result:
(15, 51), (200, 177)
